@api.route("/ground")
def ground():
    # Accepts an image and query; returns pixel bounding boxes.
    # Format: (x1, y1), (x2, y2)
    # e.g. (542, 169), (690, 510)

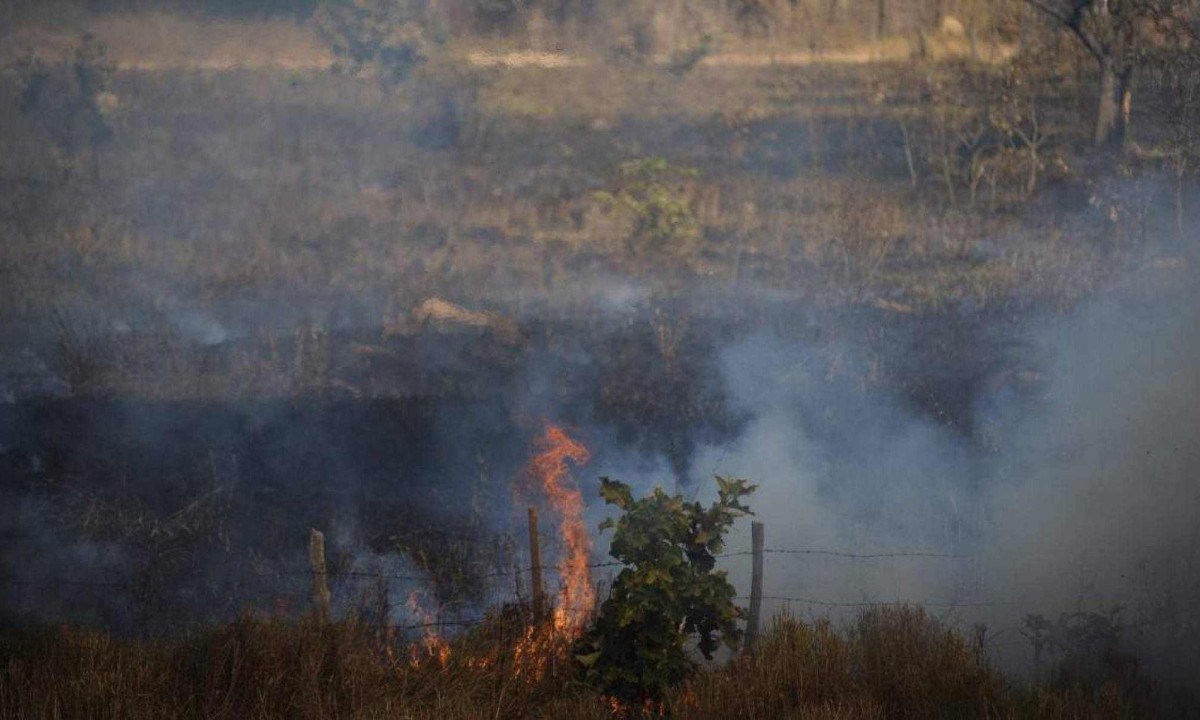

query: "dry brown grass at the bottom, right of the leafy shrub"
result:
(677, 607), (1128, 719)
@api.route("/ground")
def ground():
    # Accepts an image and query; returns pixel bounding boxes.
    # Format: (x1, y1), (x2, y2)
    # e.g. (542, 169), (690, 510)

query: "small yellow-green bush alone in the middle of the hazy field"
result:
(595, 157), (700, 260)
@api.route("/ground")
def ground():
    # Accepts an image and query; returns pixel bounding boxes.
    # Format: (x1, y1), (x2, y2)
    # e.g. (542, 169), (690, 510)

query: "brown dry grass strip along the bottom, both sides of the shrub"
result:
(0, 606), (1136, 719)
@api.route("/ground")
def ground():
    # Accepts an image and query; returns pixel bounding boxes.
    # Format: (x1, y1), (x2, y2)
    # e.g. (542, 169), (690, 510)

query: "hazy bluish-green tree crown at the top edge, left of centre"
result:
(313, 0), (436, 86)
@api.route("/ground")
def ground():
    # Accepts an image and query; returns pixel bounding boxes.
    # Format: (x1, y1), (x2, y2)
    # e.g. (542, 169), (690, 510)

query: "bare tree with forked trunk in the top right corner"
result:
(1025, 0), (1195, 148)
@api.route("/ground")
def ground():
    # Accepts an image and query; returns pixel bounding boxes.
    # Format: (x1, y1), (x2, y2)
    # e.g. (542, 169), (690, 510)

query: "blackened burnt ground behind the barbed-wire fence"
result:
(0, 289), (1031, 631)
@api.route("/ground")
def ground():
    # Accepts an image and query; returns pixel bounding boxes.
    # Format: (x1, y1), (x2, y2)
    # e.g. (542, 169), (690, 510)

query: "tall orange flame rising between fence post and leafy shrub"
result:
(529, 424), (596, 634)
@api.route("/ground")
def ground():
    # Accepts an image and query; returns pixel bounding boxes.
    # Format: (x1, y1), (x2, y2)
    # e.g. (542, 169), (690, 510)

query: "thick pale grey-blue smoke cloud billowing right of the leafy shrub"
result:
(695, 268), (1200, 670)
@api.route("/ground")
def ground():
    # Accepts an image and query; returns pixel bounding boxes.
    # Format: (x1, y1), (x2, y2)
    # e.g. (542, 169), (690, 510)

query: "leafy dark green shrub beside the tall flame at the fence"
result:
(574, 478), (755, 702)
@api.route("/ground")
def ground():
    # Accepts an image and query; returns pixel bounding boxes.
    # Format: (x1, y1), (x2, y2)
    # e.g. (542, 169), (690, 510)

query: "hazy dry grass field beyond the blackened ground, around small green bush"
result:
(0, 44), (1170, 328)
